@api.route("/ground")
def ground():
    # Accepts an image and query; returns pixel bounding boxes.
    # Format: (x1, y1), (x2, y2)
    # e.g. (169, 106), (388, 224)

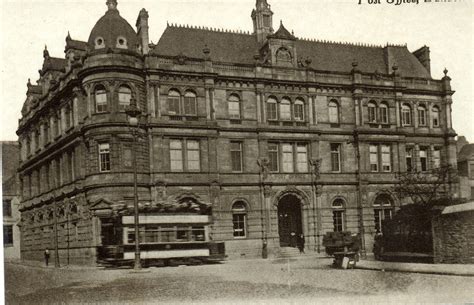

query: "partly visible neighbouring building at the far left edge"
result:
(0, 141), (20, 260)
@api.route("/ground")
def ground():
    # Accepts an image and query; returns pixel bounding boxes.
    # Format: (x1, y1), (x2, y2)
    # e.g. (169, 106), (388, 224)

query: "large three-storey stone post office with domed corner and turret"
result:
(17, 0), (456, 263)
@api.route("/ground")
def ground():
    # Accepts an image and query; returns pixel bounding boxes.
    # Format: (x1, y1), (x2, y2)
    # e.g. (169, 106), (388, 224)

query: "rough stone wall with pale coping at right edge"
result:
(432, 202), (474, 264)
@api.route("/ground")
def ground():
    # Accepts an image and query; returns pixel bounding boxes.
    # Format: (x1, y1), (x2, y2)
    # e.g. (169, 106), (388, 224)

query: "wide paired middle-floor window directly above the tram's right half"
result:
(170, 139), (201, 172)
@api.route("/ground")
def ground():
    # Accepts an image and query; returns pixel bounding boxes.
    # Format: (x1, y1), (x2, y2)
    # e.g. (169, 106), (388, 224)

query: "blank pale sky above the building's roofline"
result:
(0, 0), (474, 142)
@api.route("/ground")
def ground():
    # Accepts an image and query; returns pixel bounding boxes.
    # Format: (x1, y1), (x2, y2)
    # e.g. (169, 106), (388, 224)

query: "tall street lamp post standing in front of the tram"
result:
(125, 96), (142, 270)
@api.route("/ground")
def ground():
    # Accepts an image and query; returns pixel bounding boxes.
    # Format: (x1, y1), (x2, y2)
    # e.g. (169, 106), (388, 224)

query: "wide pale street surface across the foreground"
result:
(5, 257), (474, 304)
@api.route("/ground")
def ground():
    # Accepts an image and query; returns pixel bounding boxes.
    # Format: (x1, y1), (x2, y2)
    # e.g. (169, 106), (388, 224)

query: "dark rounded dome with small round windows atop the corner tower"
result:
(88, 0), (138, 51)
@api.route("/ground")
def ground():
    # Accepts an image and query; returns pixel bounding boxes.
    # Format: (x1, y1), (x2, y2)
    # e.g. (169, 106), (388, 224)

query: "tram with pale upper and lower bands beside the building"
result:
(97, 210), (226, 266)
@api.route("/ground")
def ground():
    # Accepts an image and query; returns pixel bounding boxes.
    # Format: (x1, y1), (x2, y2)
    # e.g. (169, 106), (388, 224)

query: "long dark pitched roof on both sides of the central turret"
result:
(150, 25), (431, 78)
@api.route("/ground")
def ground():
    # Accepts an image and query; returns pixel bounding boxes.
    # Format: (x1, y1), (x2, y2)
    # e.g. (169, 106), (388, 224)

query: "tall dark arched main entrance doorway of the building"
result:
(278, 194), (303, 247)
